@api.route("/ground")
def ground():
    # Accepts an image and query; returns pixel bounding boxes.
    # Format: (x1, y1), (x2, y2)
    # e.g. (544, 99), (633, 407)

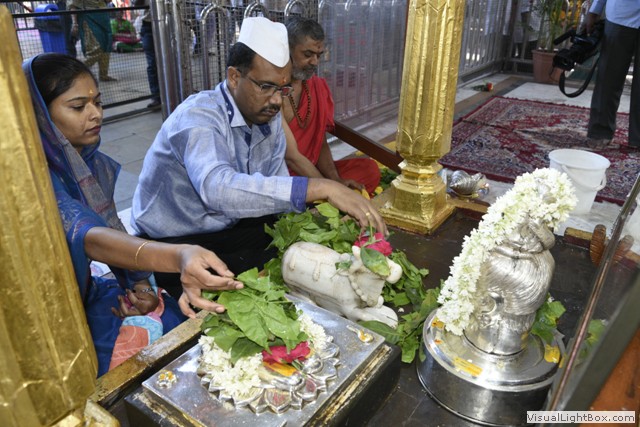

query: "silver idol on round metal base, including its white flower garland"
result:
(417, 172), (575, 425)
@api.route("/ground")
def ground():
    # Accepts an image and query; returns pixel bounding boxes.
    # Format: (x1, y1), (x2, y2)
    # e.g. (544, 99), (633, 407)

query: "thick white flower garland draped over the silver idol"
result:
(438, 168), (577, 335)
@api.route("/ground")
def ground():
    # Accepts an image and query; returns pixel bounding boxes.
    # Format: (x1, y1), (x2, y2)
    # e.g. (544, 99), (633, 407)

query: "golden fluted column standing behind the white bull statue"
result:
(382, 0), (465, 233)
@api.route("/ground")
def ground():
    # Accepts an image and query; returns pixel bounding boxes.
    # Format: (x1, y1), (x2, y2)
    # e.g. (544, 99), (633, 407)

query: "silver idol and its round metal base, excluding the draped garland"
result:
(418, 221), (564, 425)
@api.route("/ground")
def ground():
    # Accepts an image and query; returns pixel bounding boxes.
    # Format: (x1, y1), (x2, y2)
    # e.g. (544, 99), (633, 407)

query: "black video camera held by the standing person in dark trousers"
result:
(553, 20), (604, 71)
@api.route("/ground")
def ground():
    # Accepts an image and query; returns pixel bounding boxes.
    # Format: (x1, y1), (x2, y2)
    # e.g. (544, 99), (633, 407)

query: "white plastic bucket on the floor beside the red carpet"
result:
(549, 148), (611, 214)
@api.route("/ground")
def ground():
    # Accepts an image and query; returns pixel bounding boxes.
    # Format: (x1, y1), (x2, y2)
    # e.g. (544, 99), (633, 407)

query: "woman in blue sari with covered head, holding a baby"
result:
(23, 53), (242, 375)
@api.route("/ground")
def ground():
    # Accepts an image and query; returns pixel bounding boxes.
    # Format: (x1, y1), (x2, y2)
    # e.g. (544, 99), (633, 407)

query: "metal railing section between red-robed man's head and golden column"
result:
(318, 0), (407, 123)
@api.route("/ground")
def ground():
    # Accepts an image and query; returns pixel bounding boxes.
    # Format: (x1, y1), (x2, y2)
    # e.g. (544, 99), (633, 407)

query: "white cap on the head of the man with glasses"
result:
(238, 17), (289, 68)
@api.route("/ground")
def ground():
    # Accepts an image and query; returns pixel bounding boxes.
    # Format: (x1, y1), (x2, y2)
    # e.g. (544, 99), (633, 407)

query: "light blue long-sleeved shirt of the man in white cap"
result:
(131, 81), (308, 238)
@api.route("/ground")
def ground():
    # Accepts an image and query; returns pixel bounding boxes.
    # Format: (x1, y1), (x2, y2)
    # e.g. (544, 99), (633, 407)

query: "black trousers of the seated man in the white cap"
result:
(150, 215), (278, 299)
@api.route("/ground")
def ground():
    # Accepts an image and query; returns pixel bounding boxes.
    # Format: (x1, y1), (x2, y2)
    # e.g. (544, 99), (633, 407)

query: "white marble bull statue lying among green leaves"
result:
(282, 242), (402, 328)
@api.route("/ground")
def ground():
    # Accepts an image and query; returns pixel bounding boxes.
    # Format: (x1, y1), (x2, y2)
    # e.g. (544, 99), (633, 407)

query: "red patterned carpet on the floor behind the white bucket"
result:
(440, 97), (640, 204)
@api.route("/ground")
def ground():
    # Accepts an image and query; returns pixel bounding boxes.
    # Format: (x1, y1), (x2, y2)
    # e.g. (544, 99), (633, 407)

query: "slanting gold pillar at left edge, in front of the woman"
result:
(0, 6), (108, 426)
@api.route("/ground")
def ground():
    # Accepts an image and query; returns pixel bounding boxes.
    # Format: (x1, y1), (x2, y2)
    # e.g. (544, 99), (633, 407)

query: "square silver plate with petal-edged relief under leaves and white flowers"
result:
(142, 301), (384, 426)
